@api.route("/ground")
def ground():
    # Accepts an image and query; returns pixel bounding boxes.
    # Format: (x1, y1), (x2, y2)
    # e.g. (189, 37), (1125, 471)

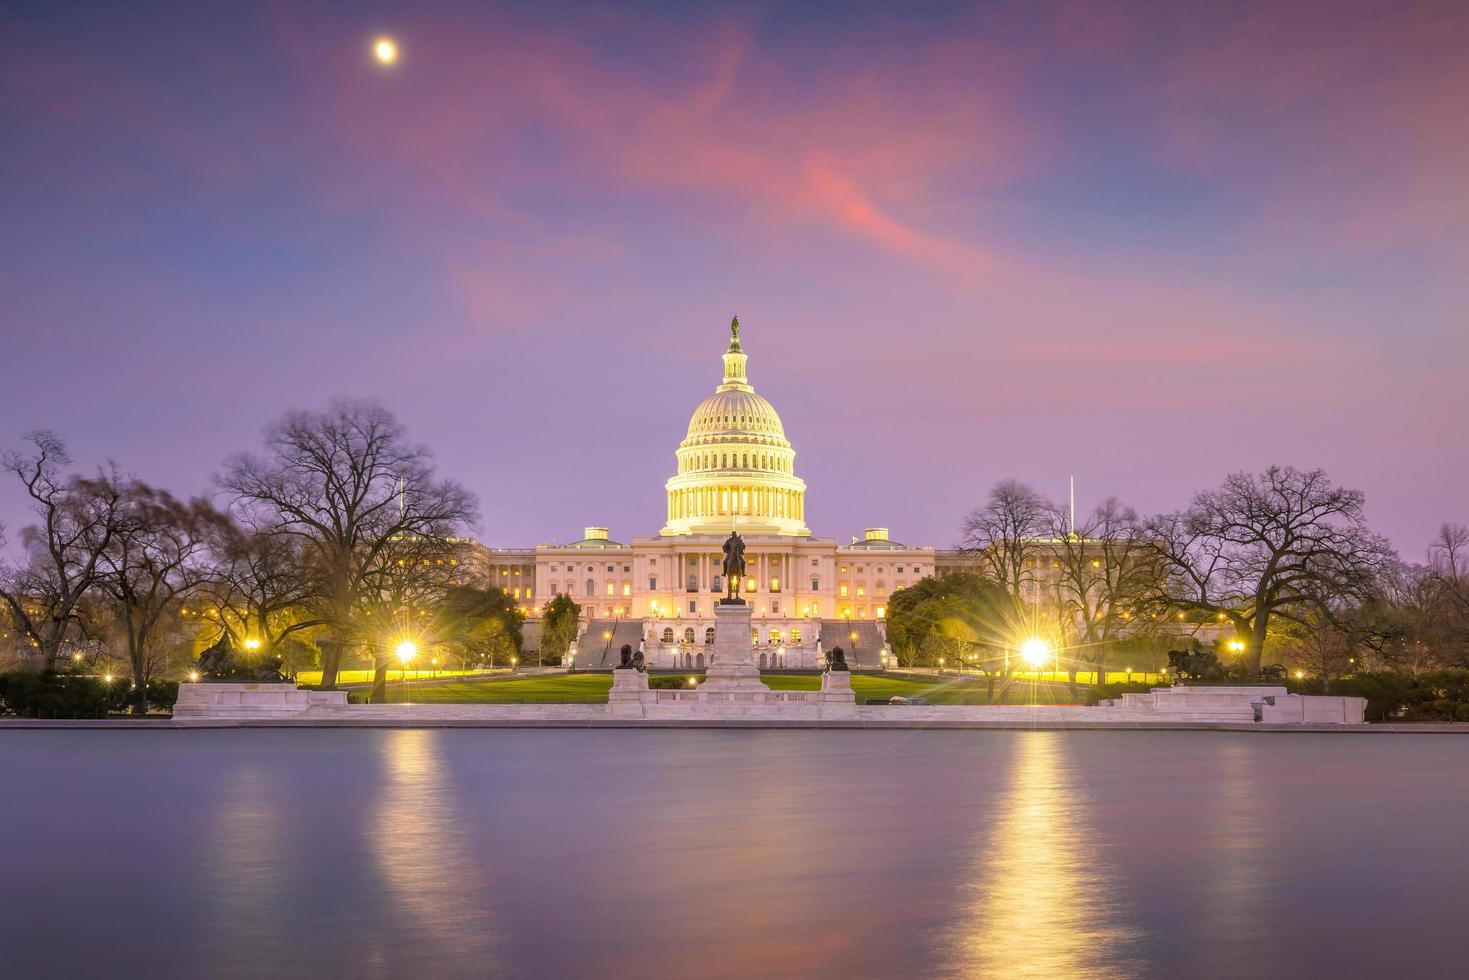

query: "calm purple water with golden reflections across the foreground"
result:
(0, 730), (1469, 977)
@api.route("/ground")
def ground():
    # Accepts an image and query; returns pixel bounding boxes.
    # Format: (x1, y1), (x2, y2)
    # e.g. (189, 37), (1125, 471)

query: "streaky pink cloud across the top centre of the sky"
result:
(273, 8), (1031, 276)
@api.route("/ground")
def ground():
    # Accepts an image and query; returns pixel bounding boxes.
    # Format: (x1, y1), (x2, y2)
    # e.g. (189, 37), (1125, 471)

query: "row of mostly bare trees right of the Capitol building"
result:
(887, 467), (1469, 685)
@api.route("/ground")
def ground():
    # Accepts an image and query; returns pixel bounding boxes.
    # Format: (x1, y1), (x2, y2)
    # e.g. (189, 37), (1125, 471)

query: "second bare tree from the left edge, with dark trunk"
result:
(93, 480), (220, 714)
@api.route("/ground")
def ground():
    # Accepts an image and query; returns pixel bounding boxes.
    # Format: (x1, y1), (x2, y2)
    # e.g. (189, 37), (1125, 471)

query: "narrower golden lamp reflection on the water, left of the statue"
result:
(373, 730), (498, 973)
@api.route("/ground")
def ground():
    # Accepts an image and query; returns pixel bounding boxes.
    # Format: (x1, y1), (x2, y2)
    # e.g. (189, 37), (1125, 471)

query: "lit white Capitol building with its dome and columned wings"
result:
(476, 319), (961, 669)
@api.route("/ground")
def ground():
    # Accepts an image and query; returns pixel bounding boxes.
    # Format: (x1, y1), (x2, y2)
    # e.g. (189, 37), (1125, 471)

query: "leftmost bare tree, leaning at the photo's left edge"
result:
(0, 432), (120, 664)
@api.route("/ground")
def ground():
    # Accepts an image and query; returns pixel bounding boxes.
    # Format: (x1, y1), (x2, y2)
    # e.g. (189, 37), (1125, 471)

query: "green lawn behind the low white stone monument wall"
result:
(373, 674), (1104, 704)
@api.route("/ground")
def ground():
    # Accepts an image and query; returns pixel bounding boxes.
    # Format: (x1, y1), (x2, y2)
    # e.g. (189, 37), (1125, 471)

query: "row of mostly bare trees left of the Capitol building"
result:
(0, 401), (574, 711)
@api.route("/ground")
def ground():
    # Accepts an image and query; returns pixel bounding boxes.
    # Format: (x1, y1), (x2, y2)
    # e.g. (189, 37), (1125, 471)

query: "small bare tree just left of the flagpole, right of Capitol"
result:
(961, 480), (1055, 599)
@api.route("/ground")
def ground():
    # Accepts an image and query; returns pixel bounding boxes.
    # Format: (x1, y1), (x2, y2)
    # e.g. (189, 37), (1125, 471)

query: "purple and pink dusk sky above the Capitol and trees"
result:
(0, 0), (1469, 560)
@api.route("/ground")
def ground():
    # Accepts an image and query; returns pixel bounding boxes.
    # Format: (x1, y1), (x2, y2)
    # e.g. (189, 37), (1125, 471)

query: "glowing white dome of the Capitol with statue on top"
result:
(663, 317), (811, 535)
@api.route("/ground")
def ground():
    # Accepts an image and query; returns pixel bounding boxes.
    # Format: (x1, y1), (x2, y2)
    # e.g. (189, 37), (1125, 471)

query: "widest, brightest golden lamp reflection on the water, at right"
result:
(956, 732), (1140, 979)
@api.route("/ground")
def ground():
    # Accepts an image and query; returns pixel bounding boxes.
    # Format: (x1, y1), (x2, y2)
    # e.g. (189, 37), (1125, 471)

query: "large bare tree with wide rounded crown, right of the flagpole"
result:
(1147, 466), (1394, 670)
